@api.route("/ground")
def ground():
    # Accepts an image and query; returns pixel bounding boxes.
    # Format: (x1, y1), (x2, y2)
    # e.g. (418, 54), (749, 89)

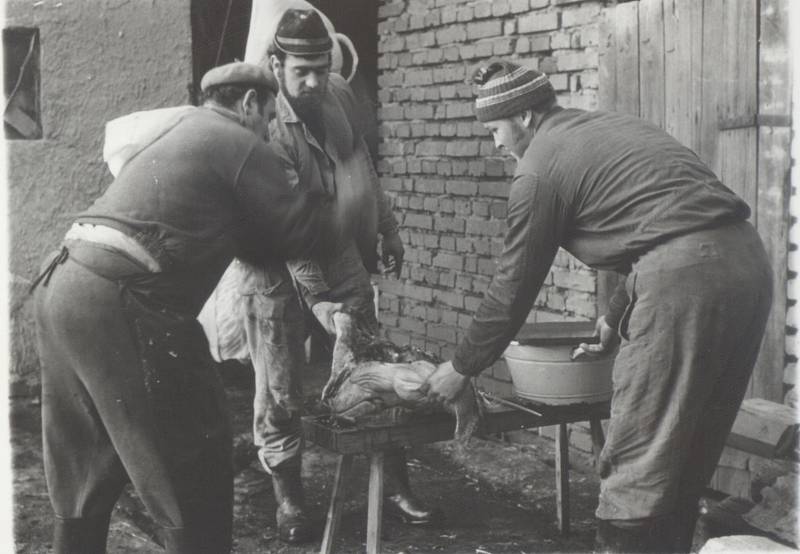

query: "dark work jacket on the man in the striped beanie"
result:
(453, 107), (750, 375)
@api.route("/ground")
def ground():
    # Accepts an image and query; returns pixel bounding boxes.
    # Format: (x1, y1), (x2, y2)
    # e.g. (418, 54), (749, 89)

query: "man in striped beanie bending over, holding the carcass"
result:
(428, 61), (772, 552)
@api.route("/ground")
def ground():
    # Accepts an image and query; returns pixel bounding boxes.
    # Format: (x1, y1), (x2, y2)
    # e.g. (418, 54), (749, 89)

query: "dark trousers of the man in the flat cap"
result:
(36, 241), (233, 554)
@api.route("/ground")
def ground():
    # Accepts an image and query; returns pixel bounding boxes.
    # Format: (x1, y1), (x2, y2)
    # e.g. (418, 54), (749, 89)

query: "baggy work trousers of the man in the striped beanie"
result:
(597, 222), (772, 539)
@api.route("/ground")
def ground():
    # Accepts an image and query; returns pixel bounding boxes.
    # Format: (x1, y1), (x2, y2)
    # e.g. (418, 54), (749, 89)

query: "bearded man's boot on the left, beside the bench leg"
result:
(272, 460), (314, 544)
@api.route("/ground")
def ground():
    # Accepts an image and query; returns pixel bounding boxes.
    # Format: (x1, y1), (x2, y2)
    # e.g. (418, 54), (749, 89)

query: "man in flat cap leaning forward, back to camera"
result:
(34, 63), (346, 554)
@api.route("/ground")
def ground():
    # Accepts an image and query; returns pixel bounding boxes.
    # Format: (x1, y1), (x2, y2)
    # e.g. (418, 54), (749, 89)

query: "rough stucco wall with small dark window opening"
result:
(5, 0), (191, 395)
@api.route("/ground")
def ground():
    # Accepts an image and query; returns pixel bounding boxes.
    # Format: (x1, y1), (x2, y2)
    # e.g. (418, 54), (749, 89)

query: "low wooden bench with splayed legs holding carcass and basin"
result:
(303, 398), (609, 554)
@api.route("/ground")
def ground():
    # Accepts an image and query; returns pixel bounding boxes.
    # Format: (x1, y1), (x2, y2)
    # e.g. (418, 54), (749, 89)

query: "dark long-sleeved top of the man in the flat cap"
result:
(78, 107), (335, 317)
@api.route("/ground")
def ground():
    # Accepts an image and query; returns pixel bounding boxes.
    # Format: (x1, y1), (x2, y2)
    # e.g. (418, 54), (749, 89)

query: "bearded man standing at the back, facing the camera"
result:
(200, 9), (437, 543)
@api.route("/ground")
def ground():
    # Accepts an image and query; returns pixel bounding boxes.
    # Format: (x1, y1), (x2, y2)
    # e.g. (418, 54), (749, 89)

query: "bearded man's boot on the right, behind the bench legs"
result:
(383, 449), (444, 525)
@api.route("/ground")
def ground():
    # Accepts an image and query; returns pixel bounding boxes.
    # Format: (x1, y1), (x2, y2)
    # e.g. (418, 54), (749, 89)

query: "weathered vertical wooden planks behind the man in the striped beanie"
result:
(598, 0), (791, 401)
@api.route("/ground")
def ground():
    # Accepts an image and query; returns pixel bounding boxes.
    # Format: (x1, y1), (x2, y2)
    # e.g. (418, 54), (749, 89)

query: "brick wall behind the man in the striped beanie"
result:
(378, 0), (603, 394)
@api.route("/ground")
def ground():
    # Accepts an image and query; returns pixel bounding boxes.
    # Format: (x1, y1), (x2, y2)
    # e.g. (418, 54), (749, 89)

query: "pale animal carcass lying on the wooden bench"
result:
(322, 312), (482, 443)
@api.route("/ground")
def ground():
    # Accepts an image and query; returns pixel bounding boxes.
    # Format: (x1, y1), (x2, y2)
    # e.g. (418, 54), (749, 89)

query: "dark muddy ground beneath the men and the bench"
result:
(12, 360), (598, 554)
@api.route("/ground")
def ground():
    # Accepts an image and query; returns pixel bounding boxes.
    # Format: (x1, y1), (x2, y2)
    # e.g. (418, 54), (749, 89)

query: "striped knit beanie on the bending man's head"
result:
(473, 61), (556, 122)
